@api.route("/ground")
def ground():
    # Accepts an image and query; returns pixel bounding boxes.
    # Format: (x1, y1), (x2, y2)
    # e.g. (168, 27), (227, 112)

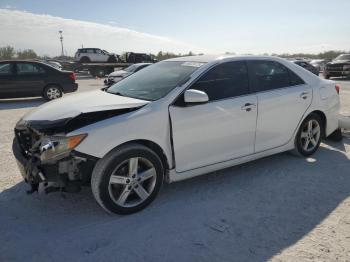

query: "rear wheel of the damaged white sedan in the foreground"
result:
(294, 113), (324, 156)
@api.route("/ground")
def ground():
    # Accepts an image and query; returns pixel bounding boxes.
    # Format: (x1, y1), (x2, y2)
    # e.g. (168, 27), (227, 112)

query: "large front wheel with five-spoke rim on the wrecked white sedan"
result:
(91, 144), (164, 215)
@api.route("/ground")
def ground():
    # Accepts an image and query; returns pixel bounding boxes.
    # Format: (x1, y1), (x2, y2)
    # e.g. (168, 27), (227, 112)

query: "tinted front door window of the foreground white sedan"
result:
(190, 61), (249, 101)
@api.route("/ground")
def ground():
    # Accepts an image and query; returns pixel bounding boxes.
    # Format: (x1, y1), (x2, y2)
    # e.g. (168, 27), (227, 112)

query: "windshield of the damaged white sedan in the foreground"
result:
(107, 61), (203, 101)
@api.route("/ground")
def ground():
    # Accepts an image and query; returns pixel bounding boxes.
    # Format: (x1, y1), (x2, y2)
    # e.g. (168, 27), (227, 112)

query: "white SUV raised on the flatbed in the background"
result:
(74, 48), (117, 63)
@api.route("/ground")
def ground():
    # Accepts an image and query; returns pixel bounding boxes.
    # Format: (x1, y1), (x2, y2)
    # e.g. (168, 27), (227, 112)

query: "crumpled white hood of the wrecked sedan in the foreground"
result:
(22, 90), (149, 121)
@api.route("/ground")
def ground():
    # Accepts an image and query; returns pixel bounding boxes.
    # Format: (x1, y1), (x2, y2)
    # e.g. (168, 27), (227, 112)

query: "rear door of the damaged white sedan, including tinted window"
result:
(248, 60), (312, 152)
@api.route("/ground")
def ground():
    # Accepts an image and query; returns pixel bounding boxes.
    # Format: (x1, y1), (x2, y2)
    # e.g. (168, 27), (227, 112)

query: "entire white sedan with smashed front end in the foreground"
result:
(13, 56), (339, 214)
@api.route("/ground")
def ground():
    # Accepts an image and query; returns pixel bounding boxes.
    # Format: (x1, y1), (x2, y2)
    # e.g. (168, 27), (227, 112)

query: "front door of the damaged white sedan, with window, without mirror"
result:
(169, 61), (257, 172)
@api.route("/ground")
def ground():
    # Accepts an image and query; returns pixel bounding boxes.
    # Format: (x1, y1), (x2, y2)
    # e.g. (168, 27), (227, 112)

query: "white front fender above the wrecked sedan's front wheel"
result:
(68, 101), (173, 167)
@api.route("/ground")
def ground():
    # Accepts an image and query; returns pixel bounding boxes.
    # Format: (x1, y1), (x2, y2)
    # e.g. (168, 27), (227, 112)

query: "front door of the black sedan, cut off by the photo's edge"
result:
(0, 62), (16, 98)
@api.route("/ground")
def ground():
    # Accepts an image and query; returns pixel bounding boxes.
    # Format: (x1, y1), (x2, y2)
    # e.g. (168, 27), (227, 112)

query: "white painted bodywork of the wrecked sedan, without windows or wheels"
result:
(22, 56), (339, 182)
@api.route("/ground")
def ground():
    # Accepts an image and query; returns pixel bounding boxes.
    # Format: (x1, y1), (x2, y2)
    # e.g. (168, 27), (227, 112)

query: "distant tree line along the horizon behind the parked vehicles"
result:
(0, 46), (346, 61)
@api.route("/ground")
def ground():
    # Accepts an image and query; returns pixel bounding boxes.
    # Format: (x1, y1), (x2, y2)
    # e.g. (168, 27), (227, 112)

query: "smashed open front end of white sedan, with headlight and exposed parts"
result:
(13, 107), (139, 193)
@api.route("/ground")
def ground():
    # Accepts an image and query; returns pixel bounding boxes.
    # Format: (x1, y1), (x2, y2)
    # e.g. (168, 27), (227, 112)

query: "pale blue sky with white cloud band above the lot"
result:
(0, 0), (350, 55)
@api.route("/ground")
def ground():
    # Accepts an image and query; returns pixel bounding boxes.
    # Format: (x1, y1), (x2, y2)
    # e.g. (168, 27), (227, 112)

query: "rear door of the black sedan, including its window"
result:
(16, 62), (46, 96)
